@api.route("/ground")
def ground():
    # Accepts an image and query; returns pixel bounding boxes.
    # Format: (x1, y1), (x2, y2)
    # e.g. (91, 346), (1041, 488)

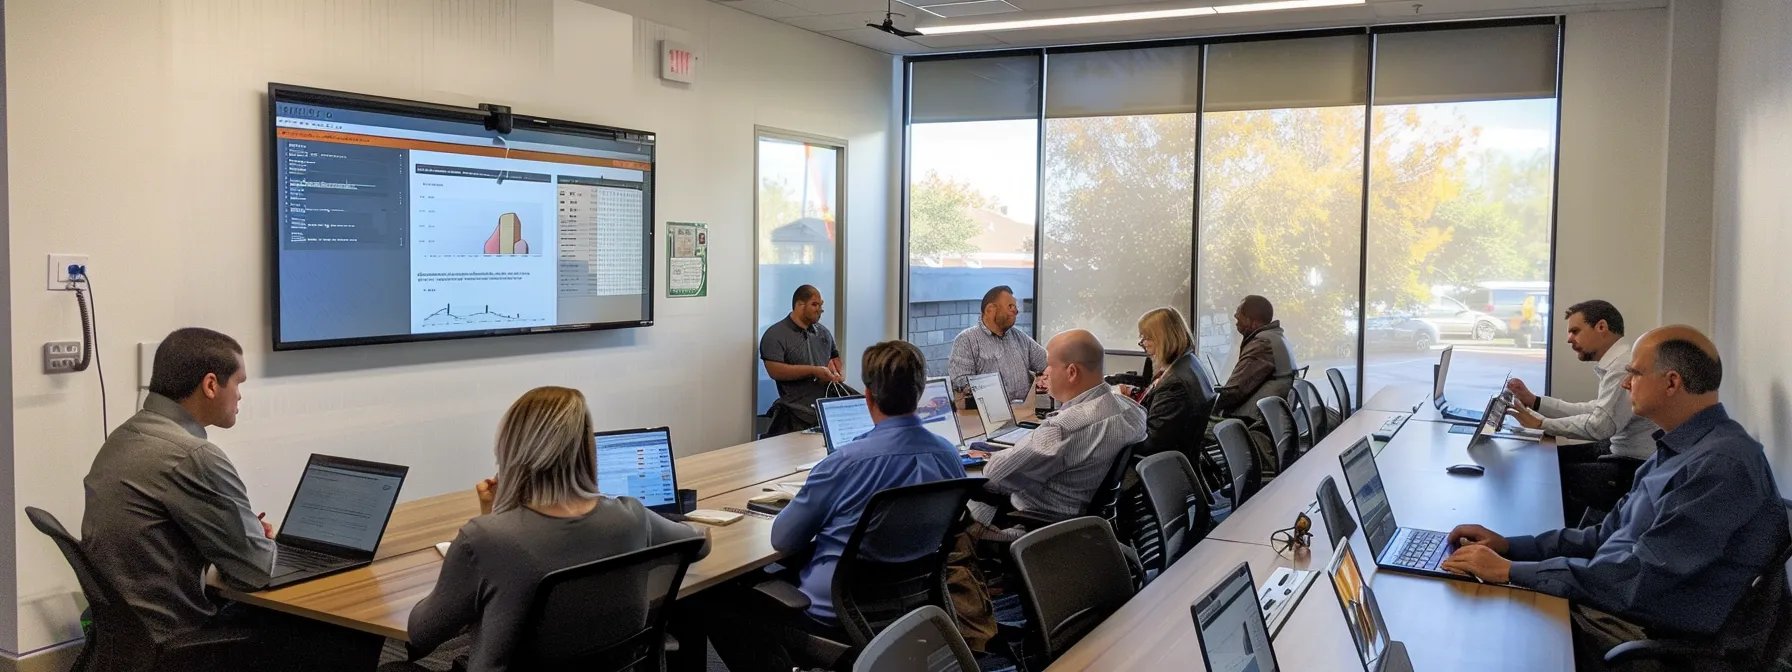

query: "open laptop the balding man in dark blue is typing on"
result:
(1321, 437), (1475, 581)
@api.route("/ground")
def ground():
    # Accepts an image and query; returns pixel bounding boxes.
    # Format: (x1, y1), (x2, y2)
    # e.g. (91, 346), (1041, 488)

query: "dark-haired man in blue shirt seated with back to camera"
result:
(713, 340), (964, 672)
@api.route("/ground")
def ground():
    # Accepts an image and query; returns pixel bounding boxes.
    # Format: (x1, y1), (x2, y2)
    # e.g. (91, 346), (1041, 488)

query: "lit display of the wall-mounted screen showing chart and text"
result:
(274, 95), (652, 344)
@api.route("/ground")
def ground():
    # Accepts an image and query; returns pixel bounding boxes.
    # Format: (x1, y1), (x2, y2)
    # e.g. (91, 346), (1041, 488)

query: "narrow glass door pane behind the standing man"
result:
(753, 131), (846, 414)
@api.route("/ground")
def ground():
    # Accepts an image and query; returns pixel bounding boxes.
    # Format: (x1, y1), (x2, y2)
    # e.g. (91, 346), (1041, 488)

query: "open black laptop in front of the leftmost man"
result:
(267, 453), (410, 588)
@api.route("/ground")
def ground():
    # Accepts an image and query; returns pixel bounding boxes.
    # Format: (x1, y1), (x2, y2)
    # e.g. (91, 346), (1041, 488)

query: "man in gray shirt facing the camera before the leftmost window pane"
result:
(946, 285), (1045, 401)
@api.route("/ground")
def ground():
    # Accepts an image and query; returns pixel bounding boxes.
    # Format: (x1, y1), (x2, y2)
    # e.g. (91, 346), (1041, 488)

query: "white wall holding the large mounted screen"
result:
(0, 0), (894, 652)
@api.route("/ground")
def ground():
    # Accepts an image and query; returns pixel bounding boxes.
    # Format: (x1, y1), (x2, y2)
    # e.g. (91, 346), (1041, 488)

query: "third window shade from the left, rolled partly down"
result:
(1206, 34), (1369, 111)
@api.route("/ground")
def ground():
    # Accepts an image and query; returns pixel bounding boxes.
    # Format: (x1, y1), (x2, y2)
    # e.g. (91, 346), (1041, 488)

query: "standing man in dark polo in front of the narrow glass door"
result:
(760, 285), (846, 435)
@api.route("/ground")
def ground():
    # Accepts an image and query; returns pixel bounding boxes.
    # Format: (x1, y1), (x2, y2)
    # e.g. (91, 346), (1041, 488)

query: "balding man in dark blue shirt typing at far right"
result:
(1443, 326), (1792, 670)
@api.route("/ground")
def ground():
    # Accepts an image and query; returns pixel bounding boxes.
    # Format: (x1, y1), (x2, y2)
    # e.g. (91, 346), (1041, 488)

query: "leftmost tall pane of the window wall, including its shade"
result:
(907, 56), (1039, 376)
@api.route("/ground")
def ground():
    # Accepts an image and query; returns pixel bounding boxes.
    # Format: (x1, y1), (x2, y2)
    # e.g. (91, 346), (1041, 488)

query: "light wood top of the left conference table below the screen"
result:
(220, 409), (1030, 640)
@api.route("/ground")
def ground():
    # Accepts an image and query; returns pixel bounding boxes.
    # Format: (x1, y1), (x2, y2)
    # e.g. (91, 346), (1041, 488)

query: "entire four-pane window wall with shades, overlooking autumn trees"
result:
(905, 20), (1566, 405)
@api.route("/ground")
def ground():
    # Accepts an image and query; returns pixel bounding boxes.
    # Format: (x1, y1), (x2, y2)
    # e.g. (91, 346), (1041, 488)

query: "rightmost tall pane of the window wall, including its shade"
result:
(1362, 25), (1555, 407)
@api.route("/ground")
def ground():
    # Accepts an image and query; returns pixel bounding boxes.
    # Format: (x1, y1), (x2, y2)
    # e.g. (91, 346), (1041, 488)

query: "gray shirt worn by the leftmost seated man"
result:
(81, 392), (274, 642)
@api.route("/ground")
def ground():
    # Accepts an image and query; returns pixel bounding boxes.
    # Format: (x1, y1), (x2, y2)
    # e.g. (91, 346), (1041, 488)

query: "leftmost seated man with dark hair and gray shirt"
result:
(81, 328), (274, 642)
